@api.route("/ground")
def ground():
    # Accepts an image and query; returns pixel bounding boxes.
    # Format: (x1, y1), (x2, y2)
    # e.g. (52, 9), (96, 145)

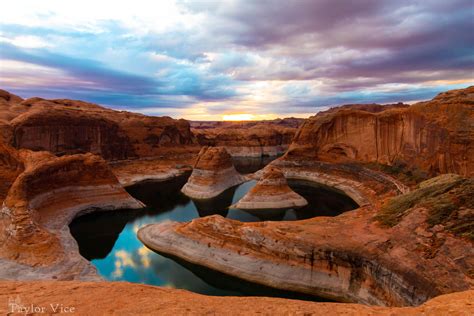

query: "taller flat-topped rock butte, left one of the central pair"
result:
(181, 147), (245, 199)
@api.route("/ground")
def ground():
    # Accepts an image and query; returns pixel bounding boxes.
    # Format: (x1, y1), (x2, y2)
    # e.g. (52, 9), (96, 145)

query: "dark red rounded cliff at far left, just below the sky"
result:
(0, 98), (195, 160)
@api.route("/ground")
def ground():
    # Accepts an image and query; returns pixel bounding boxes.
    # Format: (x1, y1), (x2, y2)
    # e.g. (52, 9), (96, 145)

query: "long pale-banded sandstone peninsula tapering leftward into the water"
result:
(138, 175), (474, 306)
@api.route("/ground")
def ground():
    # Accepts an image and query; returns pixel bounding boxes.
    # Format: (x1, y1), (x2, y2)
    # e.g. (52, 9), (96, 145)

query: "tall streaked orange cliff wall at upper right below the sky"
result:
(285, 87), (474, 176)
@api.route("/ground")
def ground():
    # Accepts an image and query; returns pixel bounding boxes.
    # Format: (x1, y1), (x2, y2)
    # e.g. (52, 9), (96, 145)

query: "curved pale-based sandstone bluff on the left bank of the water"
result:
(0, 146), (143, 279)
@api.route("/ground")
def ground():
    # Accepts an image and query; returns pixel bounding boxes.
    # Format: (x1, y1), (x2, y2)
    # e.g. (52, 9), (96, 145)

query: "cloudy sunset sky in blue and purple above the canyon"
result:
(0, 0), (474, 120)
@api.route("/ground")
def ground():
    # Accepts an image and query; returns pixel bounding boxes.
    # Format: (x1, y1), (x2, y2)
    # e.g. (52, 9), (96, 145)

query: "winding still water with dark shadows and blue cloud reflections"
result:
(70, 173), (356, 298)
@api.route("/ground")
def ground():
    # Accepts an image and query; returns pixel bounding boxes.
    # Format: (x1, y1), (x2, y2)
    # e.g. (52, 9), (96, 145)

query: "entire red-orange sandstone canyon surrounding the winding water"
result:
(0, 87), (474, 314)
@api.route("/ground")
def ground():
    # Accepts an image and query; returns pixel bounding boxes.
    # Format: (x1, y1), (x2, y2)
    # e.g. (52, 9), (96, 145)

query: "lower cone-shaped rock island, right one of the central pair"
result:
(234, 167), (308, 210)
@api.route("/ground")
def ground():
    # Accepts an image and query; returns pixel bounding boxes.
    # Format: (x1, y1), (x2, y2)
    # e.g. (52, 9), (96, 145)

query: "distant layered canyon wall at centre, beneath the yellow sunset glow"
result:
(191, 119), (302, 157)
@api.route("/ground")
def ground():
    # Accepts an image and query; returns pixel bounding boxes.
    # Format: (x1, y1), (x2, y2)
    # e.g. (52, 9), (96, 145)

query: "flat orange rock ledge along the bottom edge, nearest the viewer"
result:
(0, 281), (474, 315)
